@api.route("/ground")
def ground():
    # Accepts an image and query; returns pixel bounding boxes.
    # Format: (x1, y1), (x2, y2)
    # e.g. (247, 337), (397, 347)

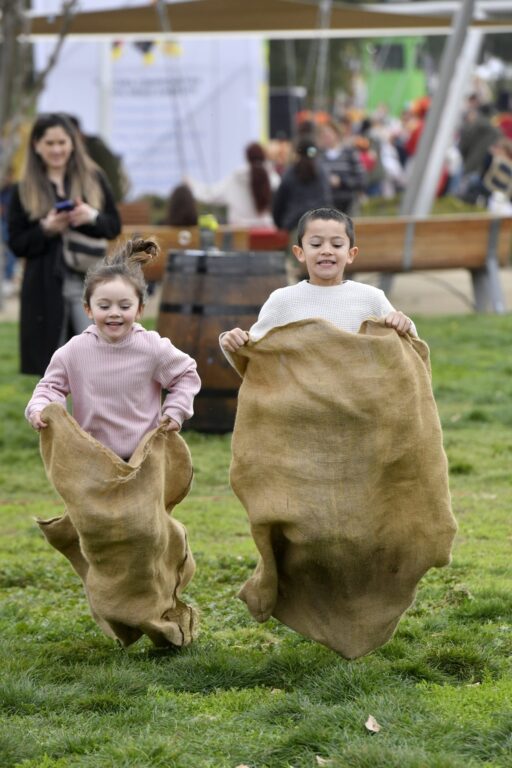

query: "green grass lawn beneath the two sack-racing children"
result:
(0, 316), (512, 768)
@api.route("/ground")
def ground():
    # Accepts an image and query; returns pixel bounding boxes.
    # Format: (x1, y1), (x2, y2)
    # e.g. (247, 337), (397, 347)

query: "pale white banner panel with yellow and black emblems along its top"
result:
(111, 39), (264, 194)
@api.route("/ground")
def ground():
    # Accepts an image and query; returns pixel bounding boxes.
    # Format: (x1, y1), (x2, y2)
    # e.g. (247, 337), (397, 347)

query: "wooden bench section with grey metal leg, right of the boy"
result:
(346, 214), (512, 313)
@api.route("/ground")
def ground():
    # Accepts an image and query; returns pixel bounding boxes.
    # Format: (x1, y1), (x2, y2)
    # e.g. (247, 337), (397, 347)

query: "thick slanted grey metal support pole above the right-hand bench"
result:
(400, 0), (475, 216)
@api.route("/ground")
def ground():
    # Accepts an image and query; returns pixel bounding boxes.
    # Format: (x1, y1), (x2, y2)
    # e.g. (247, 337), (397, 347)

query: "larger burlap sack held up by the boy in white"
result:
(231, 320), (456, 658)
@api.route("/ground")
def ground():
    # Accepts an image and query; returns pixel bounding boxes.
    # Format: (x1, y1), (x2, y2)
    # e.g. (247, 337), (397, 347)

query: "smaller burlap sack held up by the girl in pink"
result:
(37, 405), (197, 646)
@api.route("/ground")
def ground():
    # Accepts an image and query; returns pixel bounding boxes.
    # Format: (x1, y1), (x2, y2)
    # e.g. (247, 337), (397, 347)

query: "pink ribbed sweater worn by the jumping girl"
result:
(25, 323), (201, 458)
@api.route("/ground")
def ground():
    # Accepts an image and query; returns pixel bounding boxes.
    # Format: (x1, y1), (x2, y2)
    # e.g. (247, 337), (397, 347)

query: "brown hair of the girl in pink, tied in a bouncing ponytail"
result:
(83, 238), (160, 307)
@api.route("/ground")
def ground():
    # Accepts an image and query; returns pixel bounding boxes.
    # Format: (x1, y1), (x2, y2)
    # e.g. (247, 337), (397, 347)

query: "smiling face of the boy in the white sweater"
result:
(293, 219), (357, 287)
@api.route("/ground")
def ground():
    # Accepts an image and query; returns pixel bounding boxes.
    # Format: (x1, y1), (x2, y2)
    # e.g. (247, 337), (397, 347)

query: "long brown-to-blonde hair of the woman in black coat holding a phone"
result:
(20, 112), (104, 219)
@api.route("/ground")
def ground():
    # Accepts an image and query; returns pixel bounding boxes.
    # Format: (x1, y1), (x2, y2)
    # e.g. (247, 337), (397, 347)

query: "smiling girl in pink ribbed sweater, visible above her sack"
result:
(25, 239), (201, 460)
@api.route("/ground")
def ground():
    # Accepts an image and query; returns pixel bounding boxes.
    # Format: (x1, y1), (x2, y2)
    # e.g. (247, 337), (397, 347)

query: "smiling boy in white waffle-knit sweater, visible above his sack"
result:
(220, 208), (417, 362)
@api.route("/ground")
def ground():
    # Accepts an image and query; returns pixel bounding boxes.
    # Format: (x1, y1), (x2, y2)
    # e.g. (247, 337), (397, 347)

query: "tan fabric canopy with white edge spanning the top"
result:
(25, 0), (512, 40)
